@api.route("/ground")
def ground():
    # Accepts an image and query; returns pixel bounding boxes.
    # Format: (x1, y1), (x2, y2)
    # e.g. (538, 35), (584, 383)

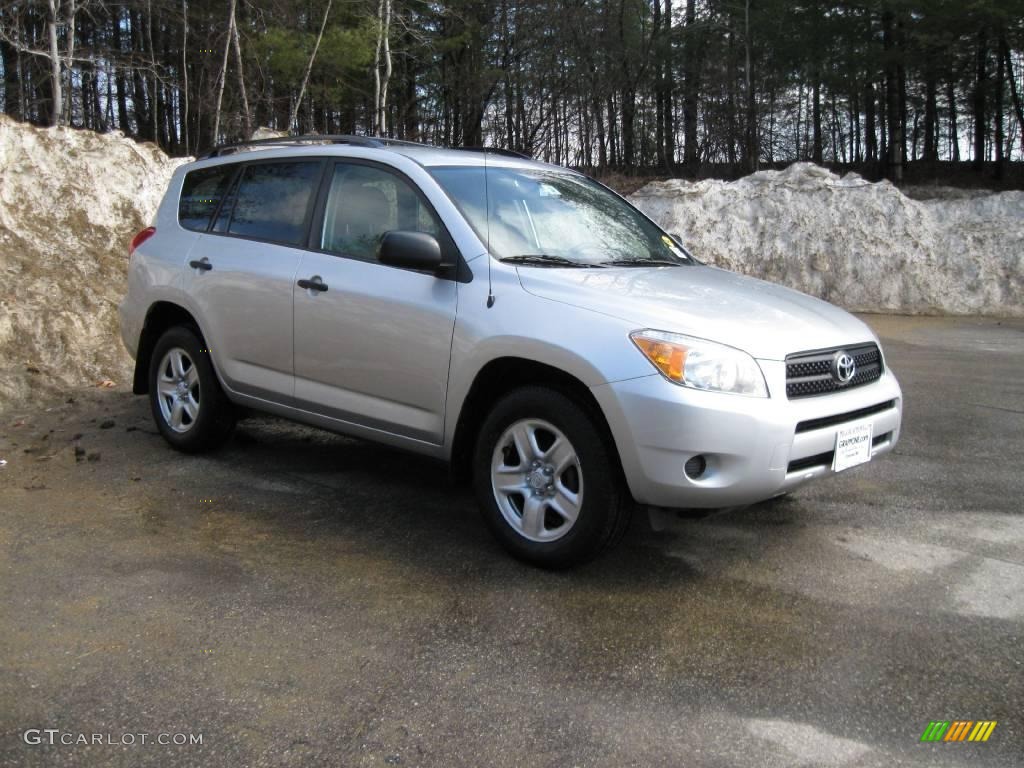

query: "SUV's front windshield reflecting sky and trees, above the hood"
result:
(429, 166), (695, 266)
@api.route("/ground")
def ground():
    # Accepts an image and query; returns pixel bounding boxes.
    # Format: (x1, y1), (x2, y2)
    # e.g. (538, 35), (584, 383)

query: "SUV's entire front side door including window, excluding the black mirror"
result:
(295, 161), (458, 444)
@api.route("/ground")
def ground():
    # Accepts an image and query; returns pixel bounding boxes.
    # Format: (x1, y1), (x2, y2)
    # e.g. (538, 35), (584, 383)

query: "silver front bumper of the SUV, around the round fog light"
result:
(592, 360), (903, 508)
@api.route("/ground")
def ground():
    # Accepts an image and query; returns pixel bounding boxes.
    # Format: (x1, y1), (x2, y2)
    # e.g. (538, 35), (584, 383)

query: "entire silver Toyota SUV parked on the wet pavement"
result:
(121, 136), (902, 566)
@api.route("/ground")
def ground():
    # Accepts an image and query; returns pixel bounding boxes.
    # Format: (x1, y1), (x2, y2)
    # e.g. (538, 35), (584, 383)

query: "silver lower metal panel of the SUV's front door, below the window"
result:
(295, 253), (457, 444)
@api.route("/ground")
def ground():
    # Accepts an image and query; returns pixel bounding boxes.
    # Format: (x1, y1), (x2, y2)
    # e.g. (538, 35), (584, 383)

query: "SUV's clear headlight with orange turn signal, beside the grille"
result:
(630, 330), (768, 397)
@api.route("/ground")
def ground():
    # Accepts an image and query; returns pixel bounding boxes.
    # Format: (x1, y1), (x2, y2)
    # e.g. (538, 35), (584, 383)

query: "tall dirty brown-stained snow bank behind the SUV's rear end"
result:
(0, 115), (183, 409)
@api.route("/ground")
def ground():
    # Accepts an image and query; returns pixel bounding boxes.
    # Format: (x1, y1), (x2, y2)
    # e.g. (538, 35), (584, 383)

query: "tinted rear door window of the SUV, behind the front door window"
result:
(218, 160), (322, 246)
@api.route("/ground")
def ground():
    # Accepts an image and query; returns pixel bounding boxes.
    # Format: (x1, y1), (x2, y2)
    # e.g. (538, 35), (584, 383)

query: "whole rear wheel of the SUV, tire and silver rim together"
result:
(150, 326), (234, 453)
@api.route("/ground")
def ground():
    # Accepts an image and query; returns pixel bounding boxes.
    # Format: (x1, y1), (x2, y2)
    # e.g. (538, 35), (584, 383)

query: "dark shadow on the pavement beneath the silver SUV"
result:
(180, 415), (733, 586)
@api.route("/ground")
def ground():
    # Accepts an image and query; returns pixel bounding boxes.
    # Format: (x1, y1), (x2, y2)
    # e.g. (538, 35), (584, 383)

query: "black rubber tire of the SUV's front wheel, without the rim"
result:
(473, 386), (634, 568)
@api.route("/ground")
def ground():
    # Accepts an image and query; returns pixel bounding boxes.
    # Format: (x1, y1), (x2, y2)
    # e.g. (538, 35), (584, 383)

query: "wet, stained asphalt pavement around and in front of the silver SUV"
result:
(0, 317), (1024, 768)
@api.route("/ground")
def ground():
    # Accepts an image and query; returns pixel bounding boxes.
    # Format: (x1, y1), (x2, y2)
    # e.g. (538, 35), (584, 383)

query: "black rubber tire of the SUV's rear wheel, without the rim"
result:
(148, 326), (234, 454)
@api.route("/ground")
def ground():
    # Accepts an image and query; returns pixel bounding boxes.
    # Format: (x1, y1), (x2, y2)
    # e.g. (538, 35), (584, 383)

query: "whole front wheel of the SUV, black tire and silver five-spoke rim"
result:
(473, 387), (631, 567)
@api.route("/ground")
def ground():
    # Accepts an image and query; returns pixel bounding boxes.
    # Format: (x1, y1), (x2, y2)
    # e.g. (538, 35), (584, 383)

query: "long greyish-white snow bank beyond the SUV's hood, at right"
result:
(630, 163), (1024, 316)
